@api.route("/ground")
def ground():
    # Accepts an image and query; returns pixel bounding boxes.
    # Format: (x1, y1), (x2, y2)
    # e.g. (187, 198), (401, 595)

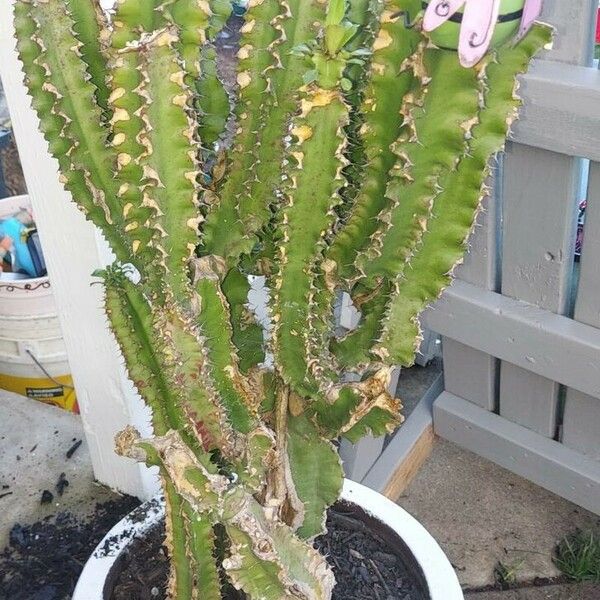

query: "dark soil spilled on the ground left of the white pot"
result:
(0, 496), (139, 600)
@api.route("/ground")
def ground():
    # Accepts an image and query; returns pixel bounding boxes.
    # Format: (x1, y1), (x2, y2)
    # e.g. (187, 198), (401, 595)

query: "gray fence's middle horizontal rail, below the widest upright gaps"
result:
(423, 281), (600, 398)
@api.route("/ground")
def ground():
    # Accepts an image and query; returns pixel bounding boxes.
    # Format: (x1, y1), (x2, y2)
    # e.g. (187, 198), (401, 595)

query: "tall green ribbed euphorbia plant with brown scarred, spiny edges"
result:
(15, 0), (550, 600)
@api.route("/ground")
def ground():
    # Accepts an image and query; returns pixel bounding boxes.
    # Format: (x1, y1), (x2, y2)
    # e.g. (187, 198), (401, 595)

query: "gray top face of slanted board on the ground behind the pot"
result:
(362, 374), (444, 492)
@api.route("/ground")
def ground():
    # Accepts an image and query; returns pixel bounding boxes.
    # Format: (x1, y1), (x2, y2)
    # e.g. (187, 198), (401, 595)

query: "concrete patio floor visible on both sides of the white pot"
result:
(0, 391), (600, 600)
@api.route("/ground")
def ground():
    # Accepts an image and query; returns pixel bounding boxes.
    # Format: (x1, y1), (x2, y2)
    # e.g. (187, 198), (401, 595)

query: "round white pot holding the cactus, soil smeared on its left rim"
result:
(72, 480), (464, 600)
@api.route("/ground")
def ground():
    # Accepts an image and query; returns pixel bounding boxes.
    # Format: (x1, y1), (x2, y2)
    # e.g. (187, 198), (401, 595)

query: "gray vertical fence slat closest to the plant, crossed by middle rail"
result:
(443, 192), (502, 410)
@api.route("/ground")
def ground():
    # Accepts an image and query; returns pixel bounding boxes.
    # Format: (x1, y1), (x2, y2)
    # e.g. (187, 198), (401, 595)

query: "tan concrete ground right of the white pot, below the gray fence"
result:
(398, 440), (600, 588)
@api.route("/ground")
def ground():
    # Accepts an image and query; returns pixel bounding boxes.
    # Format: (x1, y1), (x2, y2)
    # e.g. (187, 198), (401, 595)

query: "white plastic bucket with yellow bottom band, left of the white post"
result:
(0, 196), (77, 412)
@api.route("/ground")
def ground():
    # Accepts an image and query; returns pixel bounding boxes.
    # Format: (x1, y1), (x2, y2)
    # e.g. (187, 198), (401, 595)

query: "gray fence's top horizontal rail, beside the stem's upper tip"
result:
(511, 61), (600, 161)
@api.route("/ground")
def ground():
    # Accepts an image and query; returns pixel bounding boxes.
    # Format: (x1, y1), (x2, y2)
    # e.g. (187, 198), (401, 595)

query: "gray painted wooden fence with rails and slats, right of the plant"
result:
(424, 0), (600, 513)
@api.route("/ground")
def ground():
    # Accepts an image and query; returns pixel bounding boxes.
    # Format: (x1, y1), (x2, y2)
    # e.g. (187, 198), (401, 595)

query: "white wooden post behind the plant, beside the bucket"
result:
(0, 0), (158, 497)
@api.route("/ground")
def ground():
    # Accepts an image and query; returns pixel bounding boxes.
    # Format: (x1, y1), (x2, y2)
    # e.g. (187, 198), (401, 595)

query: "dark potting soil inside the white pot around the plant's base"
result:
(110, 502), (429, 600)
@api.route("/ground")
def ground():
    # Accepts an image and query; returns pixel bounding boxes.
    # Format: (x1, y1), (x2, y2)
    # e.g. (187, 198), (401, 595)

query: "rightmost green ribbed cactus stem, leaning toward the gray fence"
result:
(373, 25), (552, 364)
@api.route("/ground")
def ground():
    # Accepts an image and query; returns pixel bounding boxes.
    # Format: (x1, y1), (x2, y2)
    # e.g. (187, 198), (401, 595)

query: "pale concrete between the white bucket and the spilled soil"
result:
(0, 390), (120, 549)
